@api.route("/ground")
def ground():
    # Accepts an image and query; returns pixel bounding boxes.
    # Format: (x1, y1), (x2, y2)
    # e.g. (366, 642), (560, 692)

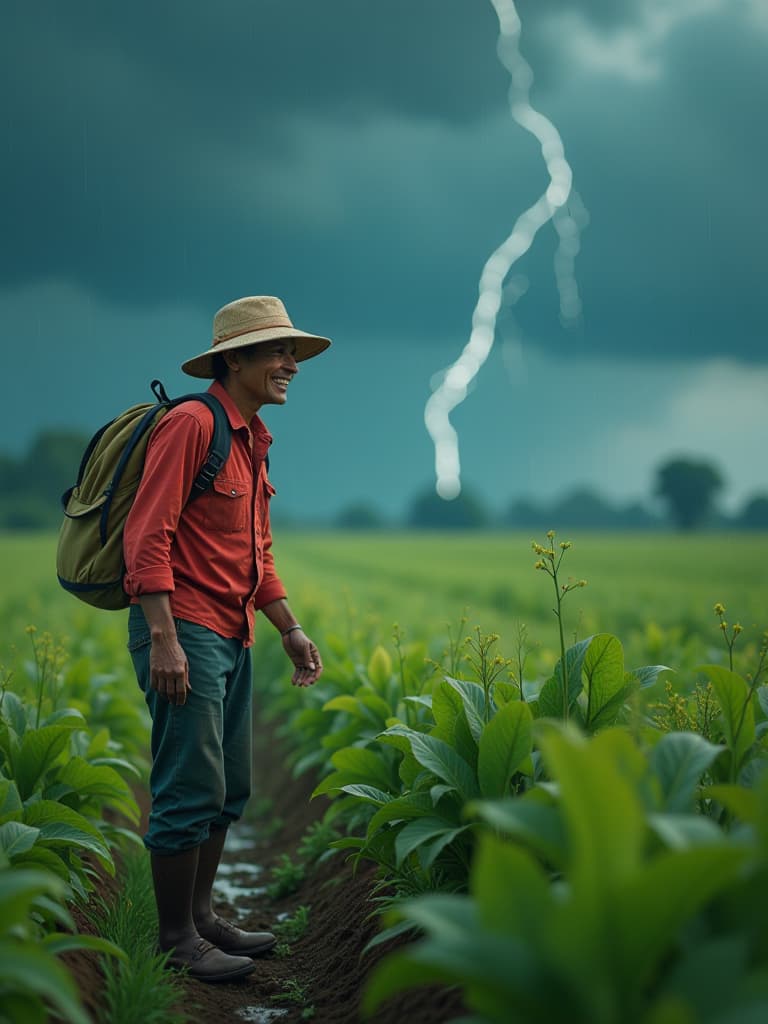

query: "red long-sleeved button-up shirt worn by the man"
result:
(123, 381), (286, 647)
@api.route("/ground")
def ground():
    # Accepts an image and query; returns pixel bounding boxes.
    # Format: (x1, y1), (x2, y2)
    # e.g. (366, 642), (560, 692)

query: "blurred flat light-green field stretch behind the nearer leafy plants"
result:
(0, 530), (768, 684)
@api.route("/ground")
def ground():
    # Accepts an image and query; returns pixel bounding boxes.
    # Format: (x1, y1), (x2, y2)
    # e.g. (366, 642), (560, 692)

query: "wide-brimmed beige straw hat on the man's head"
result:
(181, 295), (331, 377)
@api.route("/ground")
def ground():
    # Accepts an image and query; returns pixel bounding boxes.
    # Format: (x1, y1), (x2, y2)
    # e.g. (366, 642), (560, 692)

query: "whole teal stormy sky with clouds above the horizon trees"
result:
(0, 0), (768, 520)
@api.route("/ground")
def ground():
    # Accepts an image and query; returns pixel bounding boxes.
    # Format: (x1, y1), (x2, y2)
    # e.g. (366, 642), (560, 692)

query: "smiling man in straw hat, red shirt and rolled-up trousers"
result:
(124, 296), (331, 982)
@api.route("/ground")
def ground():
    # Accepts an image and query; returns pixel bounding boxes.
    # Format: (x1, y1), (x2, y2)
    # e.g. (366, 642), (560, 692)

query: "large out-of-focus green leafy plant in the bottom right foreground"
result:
(364, 724), (768, 1024)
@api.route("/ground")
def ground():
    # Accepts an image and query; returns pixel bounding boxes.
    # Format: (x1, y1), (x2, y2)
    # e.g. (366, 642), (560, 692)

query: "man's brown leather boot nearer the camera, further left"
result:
(152, 847), (256, 982)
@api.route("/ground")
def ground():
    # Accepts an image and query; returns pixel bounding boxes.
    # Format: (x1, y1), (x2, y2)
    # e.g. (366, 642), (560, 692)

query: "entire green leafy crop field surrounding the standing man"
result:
(0, 530), (768, 1024)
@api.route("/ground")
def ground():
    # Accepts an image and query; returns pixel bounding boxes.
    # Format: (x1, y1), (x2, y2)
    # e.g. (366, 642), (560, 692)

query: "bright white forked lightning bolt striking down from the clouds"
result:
(424, 0), (588, 500)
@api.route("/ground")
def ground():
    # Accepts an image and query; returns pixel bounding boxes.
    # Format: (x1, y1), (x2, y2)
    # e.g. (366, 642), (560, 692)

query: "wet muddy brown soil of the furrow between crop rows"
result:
(68, 723), (464, 1024)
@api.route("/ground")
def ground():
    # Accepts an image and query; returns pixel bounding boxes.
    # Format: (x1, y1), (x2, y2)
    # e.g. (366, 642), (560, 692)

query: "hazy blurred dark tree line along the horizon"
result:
(0, 430), (768, 530)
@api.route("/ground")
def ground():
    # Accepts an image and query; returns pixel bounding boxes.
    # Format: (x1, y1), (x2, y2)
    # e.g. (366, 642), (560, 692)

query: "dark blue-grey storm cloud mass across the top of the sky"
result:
(0, 0), (766, 358)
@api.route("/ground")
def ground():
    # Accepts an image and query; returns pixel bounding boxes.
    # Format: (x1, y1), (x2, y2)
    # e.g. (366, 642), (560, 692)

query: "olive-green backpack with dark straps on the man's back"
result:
(56, 380), (231, 610)
